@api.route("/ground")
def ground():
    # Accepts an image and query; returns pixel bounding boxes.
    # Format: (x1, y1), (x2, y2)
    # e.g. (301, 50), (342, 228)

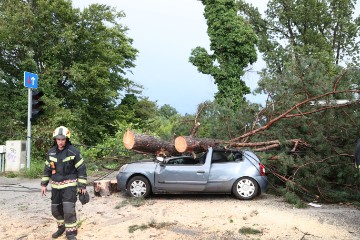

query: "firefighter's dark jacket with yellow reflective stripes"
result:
(41, 143), (87, 189)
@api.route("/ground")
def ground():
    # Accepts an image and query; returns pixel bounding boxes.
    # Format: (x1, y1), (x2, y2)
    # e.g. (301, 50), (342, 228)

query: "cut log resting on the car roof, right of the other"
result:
(175, 136), (221, 153)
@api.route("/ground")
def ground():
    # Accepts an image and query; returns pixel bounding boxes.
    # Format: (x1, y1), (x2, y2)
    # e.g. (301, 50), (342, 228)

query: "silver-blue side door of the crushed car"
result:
(155, 157), (210, 192)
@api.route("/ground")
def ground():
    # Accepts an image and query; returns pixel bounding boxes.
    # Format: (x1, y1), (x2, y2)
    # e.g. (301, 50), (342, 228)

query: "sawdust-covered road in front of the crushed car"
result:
(0, 177), (360, 240)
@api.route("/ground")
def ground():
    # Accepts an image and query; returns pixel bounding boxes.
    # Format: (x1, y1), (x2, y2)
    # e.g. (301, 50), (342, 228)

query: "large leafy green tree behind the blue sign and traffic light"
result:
(0, 0), (137, 144)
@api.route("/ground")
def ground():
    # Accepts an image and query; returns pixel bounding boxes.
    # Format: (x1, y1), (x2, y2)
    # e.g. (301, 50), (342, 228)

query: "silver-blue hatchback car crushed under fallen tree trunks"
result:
(116, 148), (268, 200)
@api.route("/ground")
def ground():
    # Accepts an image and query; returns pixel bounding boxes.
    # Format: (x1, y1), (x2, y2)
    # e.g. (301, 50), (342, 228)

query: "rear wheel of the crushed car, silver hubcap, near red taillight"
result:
(232, 177), (259, 200)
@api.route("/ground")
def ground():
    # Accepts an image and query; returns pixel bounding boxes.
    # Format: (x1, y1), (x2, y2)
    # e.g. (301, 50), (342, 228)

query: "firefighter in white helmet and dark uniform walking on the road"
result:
(41, 126), (87, 240)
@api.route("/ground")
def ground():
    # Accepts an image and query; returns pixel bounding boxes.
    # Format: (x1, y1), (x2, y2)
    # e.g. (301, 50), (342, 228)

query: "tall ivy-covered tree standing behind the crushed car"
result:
(189, 0), (257, 108)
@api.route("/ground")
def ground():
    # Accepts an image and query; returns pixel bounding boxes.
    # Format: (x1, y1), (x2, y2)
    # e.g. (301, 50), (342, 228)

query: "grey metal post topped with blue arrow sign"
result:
(24, 72), (38, 170)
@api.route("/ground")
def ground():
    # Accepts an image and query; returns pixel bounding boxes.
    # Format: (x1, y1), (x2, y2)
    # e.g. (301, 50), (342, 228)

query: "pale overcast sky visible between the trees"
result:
(73, 0), (358, 114)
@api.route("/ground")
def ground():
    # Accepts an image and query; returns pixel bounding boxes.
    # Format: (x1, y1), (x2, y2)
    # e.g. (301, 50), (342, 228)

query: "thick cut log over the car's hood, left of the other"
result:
(123, 130), (178, 156)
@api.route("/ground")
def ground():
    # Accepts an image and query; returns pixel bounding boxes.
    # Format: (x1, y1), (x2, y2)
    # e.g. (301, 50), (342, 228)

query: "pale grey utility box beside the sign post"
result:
(5, 140), (26, 172)
